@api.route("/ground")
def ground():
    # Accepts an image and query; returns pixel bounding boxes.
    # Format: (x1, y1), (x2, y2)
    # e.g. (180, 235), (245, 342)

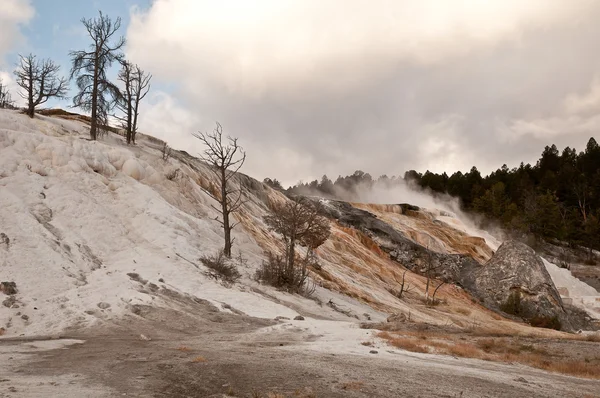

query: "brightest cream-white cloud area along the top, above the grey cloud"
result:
(128, 0), (590, 97)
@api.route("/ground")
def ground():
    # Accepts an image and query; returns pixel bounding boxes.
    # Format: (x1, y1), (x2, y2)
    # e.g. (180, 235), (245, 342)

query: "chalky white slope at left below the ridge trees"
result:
(0, 110), (384, 336)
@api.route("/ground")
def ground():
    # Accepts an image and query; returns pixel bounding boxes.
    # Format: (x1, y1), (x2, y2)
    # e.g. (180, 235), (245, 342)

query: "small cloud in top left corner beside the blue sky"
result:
(0, 0), (35, 65)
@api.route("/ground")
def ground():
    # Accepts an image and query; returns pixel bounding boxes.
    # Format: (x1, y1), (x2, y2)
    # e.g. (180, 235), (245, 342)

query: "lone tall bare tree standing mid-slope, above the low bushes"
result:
(192, 123), (246, 258)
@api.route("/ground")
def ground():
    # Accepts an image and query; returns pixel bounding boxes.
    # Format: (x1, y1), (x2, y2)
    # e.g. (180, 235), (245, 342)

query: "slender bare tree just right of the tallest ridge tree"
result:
(117, 61), (152, 144)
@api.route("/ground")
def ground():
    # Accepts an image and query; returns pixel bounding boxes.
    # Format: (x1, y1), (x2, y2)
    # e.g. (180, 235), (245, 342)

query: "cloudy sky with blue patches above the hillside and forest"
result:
(0, 0), (600, 185)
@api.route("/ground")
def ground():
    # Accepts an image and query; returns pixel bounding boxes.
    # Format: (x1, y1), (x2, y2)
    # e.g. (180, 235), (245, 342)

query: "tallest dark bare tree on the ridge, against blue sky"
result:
(70, 11), (125, 140)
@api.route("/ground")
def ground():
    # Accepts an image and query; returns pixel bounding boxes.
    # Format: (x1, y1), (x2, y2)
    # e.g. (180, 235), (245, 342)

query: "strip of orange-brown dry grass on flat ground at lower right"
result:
(377, 331), (600, 379)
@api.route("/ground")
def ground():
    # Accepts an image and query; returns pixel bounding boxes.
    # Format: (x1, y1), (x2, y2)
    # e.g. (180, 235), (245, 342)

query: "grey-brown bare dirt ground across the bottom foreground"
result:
(0, 303), (600, 398)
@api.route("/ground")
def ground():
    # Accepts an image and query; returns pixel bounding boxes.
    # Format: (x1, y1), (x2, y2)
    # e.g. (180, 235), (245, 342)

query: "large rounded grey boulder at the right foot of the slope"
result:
(475, 241), (570, 329)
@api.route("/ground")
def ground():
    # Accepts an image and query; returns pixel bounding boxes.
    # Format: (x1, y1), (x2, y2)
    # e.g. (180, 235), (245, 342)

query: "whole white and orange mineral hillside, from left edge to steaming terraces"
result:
(0, 110), (600, 396)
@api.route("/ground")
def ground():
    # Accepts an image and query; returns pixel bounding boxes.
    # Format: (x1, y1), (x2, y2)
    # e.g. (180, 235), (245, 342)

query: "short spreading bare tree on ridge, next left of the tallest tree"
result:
(14, 54), (68, 118)
